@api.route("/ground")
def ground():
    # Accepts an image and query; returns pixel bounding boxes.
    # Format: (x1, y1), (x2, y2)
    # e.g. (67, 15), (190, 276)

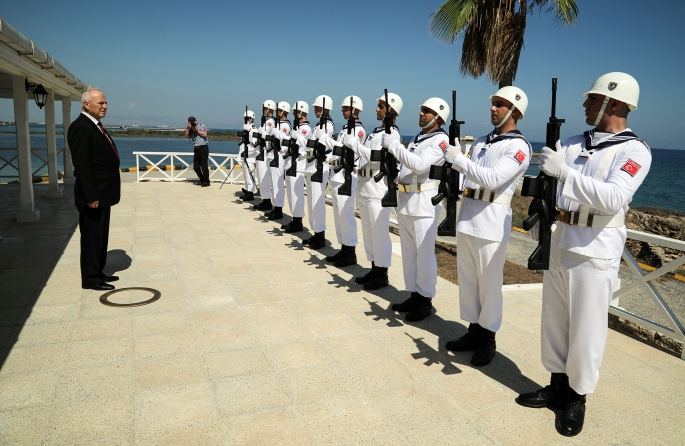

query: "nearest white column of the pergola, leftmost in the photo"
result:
(12, 76), (40, 223)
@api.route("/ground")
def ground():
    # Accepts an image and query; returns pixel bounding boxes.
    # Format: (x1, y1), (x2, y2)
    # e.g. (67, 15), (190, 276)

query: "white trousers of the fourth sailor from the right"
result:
(359, 195), (392, 268)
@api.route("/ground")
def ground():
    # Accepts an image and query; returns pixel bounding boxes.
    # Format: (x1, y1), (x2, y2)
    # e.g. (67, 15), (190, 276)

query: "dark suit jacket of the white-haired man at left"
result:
(67, 113), (121, 208)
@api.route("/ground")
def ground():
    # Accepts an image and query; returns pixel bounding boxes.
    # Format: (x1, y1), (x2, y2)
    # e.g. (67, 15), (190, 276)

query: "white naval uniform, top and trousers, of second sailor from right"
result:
(452, 130), (533, 332)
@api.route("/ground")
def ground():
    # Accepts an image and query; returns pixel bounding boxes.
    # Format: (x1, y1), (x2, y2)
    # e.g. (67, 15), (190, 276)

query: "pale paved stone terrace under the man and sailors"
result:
(0, 179), (685, 445)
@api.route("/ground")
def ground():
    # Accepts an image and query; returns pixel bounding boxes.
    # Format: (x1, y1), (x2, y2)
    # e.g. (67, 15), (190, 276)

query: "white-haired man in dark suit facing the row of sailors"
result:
(67, 89), (121, 290)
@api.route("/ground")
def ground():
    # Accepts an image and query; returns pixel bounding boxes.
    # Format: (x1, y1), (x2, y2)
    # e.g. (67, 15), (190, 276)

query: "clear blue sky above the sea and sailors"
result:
(0, 0), (685, 149)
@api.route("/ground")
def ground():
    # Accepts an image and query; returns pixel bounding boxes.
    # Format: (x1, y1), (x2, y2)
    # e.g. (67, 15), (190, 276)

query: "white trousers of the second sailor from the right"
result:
(457, 232), (507, 331)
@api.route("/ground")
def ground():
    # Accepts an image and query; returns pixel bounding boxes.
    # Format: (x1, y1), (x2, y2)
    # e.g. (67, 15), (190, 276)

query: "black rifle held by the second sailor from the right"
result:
(428, 90), (465, 237)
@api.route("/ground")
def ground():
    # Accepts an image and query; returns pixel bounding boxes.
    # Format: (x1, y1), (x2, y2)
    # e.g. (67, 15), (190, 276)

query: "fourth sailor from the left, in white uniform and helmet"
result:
(281, 101), (313, 234)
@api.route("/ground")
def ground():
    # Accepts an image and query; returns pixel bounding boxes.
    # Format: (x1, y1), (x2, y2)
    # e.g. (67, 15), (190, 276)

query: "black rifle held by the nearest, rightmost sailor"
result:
(521, 77), (566, 270)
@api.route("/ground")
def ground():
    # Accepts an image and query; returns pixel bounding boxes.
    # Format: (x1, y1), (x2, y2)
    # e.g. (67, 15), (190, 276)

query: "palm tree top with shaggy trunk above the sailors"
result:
(428, 0), (578, 88)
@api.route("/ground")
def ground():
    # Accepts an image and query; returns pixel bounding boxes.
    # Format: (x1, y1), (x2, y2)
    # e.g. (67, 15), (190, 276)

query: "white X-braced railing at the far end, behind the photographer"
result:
(133, 152), (244, 183)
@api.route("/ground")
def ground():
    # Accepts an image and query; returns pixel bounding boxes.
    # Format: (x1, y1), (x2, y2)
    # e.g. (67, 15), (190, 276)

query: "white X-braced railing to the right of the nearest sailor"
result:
(609, 229), (685, 360)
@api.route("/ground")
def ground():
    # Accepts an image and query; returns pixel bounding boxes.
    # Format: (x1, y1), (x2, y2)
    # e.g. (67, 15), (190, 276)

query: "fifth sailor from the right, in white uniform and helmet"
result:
(316, 96), (366, 268)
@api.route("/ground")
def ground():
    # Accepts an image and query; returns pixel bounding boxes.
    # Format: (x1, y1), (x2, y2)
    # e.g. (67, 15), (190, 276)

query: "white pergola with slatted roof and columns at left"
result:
(0, 17), (87, 222)
